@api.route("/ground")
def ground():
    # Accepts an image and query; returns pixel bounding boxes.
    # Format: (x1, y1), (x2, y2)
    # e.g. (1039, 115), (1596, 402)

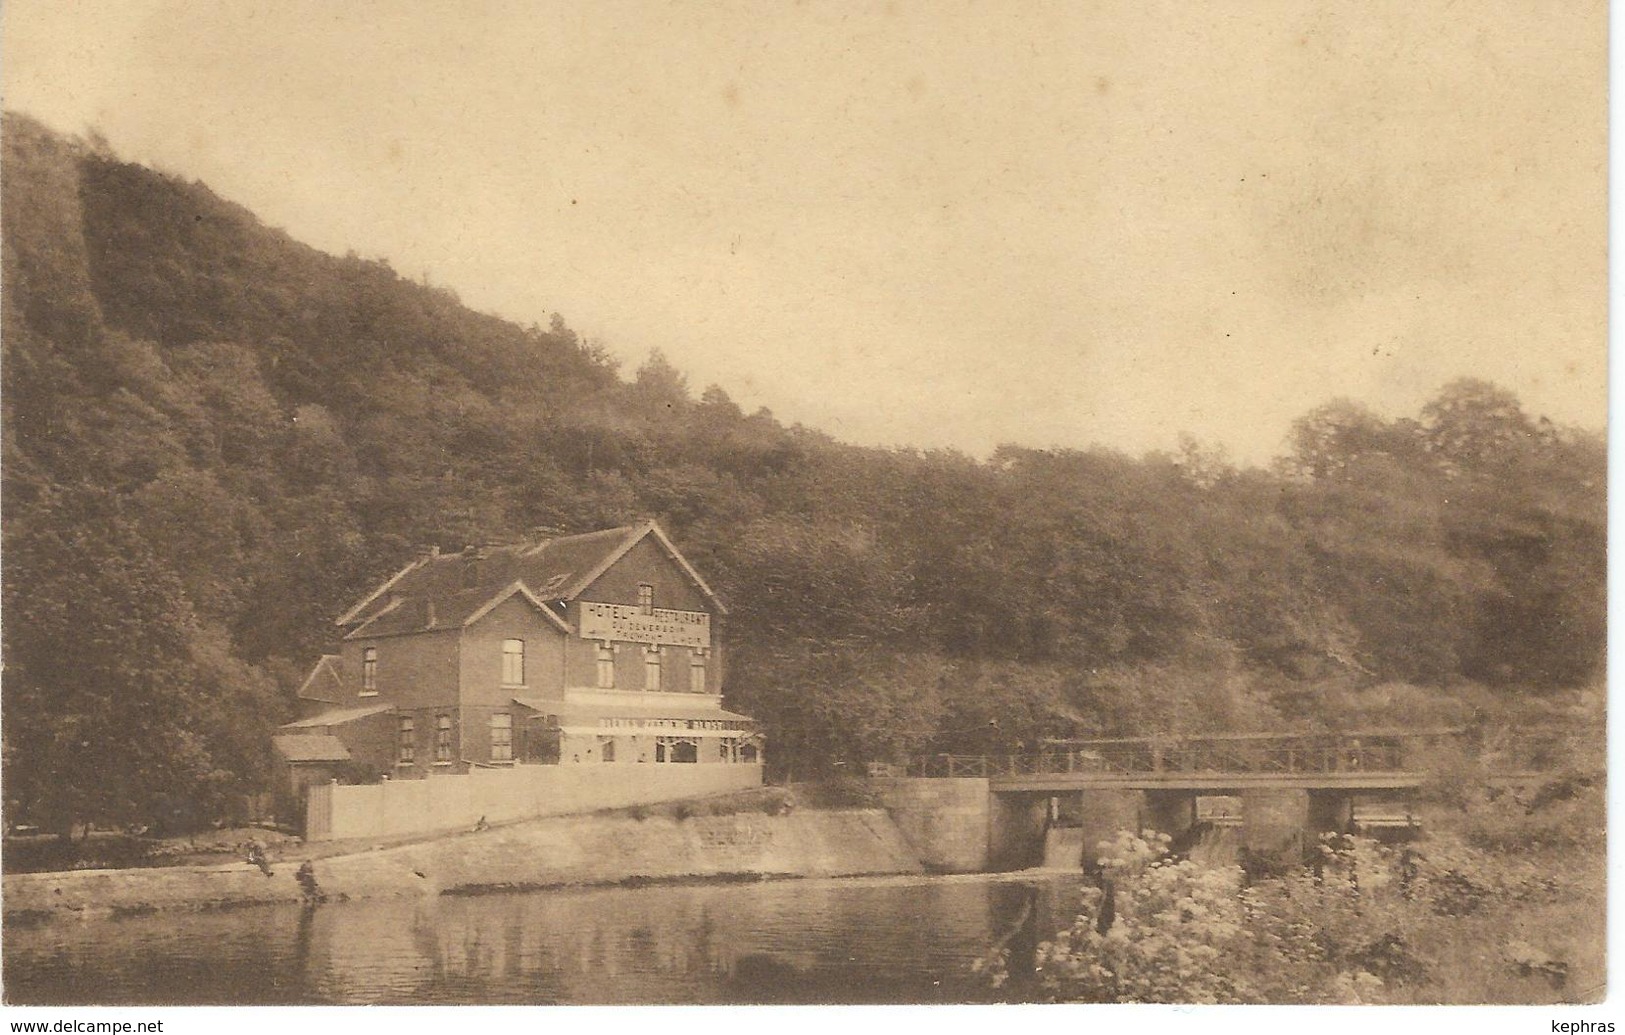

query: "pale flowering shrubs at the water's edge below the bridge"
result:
(1001, 834), (1449, 1003)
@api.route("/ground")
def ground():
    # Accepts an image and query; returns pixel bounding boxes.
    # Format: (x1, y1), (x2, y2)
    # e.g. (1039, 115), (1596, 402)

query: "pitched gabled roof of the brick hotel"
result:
(338, 522), (726, 640)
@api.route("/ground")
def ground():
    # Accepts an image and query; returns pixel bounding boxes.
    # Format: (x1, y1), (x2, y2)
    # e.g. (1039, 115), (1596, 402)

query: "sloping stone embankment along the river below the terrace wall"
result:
(0, 809), (925, 920)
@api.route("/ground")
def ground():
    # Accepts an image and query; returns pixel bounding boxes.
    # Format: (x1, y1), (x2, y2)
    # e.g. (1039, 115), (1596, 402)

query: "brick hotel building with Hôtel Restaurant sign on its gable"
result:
(281, 523), (762, 796)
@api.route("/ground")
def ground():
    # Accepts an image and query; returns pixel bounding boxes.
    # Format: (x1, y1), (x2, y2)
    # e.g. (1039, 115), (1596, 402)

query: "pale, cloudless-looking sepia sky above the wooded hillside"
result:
(0, 0), (1607, 460)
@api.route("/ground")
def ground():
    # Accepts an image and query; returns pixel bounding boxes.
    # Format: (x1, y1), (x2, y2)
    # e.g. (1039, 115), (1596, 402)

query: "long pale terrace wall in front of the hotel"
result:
(306, 764), (762, 842)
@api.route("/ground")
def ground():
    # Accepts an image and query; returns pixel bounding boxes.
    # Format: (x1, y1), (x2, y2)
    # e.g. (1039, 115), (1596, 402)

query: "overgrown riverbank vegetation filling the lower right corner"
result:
(977, 727), (1607, 1003)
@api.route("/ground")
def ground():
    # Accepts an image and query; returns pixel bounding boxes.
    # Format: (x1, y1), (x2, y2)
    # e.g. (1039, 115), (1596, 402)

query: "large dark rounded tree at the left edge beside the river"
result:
(3, 491), (268, 834)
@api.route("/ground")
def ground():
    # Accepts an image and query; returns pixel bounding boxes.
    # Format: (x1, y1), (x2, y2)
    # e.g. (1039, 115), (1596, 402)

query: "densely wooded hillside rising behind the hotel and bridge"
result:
(0, 117), (1604, 827)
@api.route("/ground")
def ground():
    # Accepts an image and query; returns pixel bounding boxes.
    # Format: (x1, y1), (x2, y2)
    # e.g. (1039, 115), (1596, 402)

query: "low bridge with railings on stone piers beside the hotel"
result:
(871, 730), (1482, 869)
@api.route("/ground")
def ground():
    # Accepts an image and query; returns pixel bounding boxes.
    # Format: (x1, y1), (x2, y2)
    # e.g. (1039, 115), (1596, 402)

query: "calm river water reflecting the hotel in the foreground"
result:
(3, 871), (1079, 1004)
